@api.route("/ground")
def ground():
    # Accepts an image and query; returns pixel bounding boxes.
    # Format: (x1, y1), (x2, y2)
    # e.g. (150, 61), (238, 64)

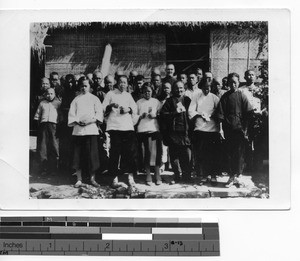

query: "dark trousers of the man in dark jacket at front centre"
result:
(169, 143), (191, 177)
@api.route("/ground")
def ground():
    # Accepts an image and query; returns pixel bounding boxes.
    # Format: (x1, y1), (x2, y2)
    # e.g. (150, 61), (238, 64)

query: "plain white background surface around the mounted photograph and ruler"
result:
(0, 0), (300, 261)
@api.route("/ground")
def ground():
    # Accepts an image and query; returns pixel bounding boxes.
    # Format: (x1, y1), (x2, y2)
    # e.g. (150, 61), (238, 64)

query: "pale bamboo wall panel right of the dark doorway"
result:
(210, 29), (268, 81)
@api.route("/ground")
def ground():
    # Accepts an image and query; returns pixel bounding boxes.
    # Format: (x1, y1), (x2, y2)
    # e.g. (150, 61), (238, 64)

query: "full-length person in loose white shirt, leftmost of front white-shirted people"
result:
(68, 76), (103, 187)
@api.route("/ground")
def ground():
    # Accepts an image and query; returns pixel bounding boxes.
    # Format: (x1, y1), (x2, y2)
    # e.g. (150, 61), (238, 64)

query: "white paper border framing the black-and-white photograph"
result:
(0, 9), (291, 210)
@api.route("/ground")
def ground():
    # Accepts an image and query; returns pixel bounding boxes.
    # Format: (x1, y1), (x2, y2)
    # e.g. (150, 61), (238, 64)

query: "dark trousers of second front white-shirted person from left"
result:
(108, 130), (138, 177)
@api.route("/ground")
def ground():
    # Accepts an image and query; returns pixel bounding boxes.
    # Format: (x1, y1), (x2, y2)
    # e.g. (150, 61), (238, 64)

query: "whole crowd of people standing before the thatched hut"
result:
(31, 64), (268, 187)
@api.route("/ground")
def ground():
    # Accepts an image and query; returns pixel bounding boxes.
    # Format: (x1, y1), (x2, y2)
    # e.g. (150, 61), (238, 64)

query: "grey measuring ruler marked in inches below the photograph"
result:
(0, 216), (220, 256)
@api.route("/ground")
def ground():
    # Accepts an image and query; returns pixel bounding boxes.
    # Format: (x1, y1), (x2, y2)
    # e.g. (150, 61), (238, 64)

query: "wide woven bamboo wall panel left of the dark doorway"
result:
(45, 30), (166, 76)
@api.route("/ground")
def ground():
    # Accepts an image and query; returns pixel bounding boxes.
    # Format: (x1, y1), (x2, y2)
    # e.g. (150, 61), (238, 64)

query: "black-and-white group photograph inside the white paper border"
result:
(29, 21), (269, 199)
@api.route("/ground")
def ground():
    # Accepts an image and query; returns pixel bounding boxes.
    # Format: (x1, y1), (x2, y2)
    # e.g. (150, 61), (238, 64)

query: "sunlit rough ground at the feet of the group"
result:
(29, 135), (269, 199)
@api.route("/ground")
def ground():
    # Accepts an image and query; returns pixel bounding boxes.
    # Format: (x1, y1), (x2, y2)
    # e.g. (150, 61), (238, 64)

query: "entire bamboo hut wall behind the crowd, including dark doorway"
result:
(45, 27), (268, 81)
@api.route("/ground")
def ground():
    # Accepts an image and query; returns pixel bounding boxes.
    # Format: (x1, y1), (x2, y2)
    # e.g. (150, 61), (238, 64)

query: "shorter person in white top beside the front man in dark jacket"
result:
(137, 83), (162, 185)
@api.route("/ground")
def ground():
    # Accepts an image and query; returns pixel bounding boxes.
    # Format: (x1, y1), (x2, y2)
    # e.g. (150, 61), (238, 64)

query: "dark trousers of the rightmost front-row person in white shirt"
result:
(193, 131), (220, 177)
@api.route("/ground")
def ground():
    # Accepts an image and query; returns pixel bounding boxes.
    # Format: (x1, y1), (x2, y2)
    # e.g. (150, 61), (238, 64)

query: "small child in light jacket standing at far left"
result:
(34, 88), (61, 172)
